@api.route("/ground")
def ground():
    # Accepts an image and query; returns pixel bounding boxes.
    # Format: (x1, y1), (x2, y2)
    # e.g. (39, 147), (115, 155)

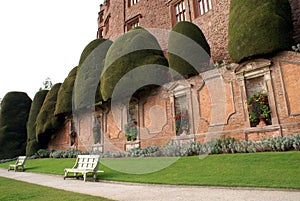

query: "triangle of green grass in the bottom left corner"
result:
(0, 177), (109, 201)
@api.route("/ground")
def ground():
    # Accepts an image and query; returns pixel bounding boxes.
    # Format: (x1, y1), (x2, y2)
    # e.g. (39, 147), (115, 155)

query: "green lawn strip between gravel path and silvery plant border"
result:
(0, 152), (300, 189)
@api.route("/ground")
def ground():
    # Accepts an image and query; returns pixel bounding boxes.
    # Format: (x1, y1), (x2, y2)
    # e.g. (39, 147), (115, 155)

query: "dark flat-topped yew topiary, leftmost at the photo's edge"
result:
(0, 92), (32, 159)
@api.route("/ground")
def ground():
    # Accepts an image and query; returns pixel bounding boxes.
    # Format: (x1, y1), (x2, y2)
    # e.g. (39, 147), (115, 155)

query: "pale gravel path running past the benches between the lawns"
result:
(0, 169), (300, 201)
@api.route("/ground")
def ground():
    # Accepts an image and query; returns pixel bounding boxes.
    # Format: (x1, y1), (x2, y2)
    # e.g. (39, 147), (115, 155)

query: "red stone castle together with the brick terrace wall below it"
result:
(48, 0), (300, 152)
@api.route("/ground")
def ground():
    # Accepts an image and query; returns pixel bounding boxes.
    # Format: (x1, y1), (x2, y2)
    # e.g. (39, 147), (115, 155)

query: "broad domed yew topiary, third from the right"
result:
(100, 27), (168, 101)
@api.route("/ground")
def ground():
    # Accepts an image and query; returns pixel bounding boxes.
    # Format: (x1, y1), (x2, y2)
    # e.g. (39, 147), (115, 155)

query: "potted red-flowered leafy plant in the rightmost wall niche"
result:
(248, 92), (271, 127)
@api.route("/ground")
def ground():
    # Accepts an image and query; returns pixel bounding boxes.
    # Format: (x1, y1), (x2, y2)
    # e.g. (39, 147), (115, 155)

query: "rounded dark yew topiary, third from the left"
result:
(36, 83), (64, 148)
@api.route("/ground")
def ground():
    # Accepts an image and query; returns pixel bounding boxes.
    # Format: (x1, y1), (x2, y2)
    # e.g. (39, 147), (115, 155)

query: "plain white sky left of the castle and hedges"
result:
(0, 0), (103, 99)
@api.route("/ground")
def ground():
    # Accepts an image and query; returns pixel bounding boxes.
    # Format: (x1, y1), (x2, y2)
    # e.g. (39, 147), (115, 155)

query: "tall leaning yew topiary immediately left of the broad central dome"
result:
(73, 39), (112, 110)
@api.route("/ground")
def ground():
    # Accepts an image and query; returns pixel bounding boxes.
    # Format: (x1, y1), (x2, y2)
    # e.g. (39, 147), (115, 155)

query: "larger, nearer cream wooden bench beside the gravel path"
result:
(64, 155), (104, 181)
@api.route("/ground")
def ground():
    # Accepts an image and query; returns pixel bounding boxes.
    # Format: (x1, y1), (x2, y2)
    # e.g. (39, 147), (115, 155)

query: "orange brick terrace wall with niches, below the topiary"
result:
(49, 52), (300, 152)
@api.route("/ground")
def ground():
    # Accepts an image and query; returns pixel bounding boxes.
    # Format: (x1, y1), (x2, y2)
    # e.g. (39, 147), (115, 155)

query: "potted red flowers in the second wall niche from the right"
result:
(174, 111), (190, 135)
